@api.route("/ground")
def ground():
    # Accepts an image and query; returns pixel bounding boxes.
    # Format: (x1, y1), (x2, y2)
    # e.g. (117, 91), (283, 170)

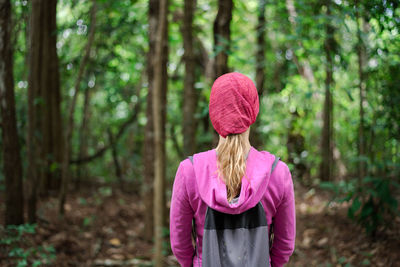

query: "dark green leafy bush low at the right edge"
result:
(320, 160), (400, 236)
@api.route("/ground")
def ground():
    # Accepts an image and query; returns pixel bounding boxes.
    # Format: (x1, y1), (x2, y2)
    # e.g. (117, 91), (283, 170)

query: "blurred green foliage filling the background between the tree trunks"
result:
(5, 0), (400, 250)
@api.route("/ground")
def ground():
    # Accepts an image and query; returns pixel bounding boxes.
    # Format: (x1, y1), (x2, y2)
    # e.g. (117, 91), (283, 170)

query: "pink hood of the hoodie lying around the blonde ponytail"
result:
(193, 146), (275, 214)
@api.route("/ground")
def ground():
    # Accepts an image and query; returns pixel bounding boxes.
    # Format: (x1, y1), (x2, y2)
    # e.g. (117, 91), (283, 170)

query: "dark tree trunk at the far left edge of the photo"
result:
(0, 0), (24, 225)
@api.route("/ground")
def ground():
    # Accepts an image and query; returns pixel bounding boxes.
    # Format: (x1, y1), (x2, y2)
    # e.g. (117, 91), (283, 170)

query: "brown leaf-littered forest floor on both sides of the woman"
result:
(0, 181), (400, 267)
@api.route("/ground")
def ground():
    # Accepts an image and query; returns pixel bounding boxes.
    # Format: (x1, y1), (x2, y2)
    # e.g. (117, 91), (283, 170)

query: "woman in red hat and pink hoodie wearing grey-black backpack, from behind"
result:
(170, 72), (296, 267)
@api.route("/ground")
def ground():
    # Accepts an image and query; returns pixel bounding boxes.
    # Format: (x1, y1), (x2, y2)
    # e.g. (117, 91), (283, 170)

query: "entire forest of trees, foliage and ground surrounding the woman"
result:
(0, 0), (400, 267)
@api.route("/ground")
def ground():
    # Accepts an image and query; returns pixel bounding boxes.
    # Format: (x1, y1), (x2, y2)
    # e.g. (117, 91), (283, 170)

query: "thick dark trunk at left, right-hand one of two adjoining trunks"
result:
(36, 0), (63, 196)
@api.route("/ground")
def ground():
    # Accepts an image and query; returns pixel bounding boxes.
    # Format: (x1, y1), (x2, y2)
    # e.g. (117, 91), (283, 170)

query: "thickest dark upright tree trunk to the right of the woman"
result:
(320, 0), (335, 181)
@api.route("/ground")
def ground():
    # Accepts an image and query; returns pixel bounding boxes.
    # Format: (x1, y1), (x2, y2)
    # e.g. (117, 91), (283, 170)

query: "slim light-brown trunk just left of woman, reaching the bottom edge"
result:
(152, 0), (168, 267)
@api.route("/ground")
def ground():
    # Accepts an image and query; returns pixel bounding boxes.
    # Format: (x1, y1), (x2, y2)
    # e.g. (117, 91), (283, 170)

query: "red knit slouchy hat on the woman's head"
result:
(209, 72), (259, 138)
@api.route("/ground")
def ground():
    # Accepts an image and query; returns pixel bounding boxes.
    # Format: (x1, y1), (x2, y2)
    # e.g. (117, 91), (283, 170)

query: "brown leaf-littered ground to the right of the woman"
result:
(288, 184), (400, 267)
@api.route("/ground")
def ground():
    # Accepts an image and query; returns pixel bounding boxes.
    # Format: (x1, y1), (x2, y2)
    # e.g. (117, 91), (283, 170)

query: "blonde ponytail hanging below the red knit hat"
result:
(216, 133), (246, 202)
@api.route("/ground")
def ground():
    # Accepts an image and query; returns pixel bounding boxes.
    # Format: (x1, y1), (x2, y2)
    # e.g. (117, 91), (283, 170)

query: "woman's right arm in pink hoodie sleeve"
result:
(270, 164), (296, 267)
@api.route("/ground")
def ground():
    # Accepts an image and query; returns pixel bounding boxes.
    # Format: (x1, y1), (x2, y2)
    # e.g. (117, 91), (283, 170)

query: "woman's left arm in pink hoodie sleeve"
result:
(170, 162), (194, 267)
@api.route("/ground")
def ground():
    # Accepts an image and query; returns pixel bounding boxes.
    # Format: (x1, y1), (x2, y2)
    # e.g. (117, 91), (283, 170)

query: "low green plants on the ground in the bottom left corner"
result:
(0, 224), (56, 267)
